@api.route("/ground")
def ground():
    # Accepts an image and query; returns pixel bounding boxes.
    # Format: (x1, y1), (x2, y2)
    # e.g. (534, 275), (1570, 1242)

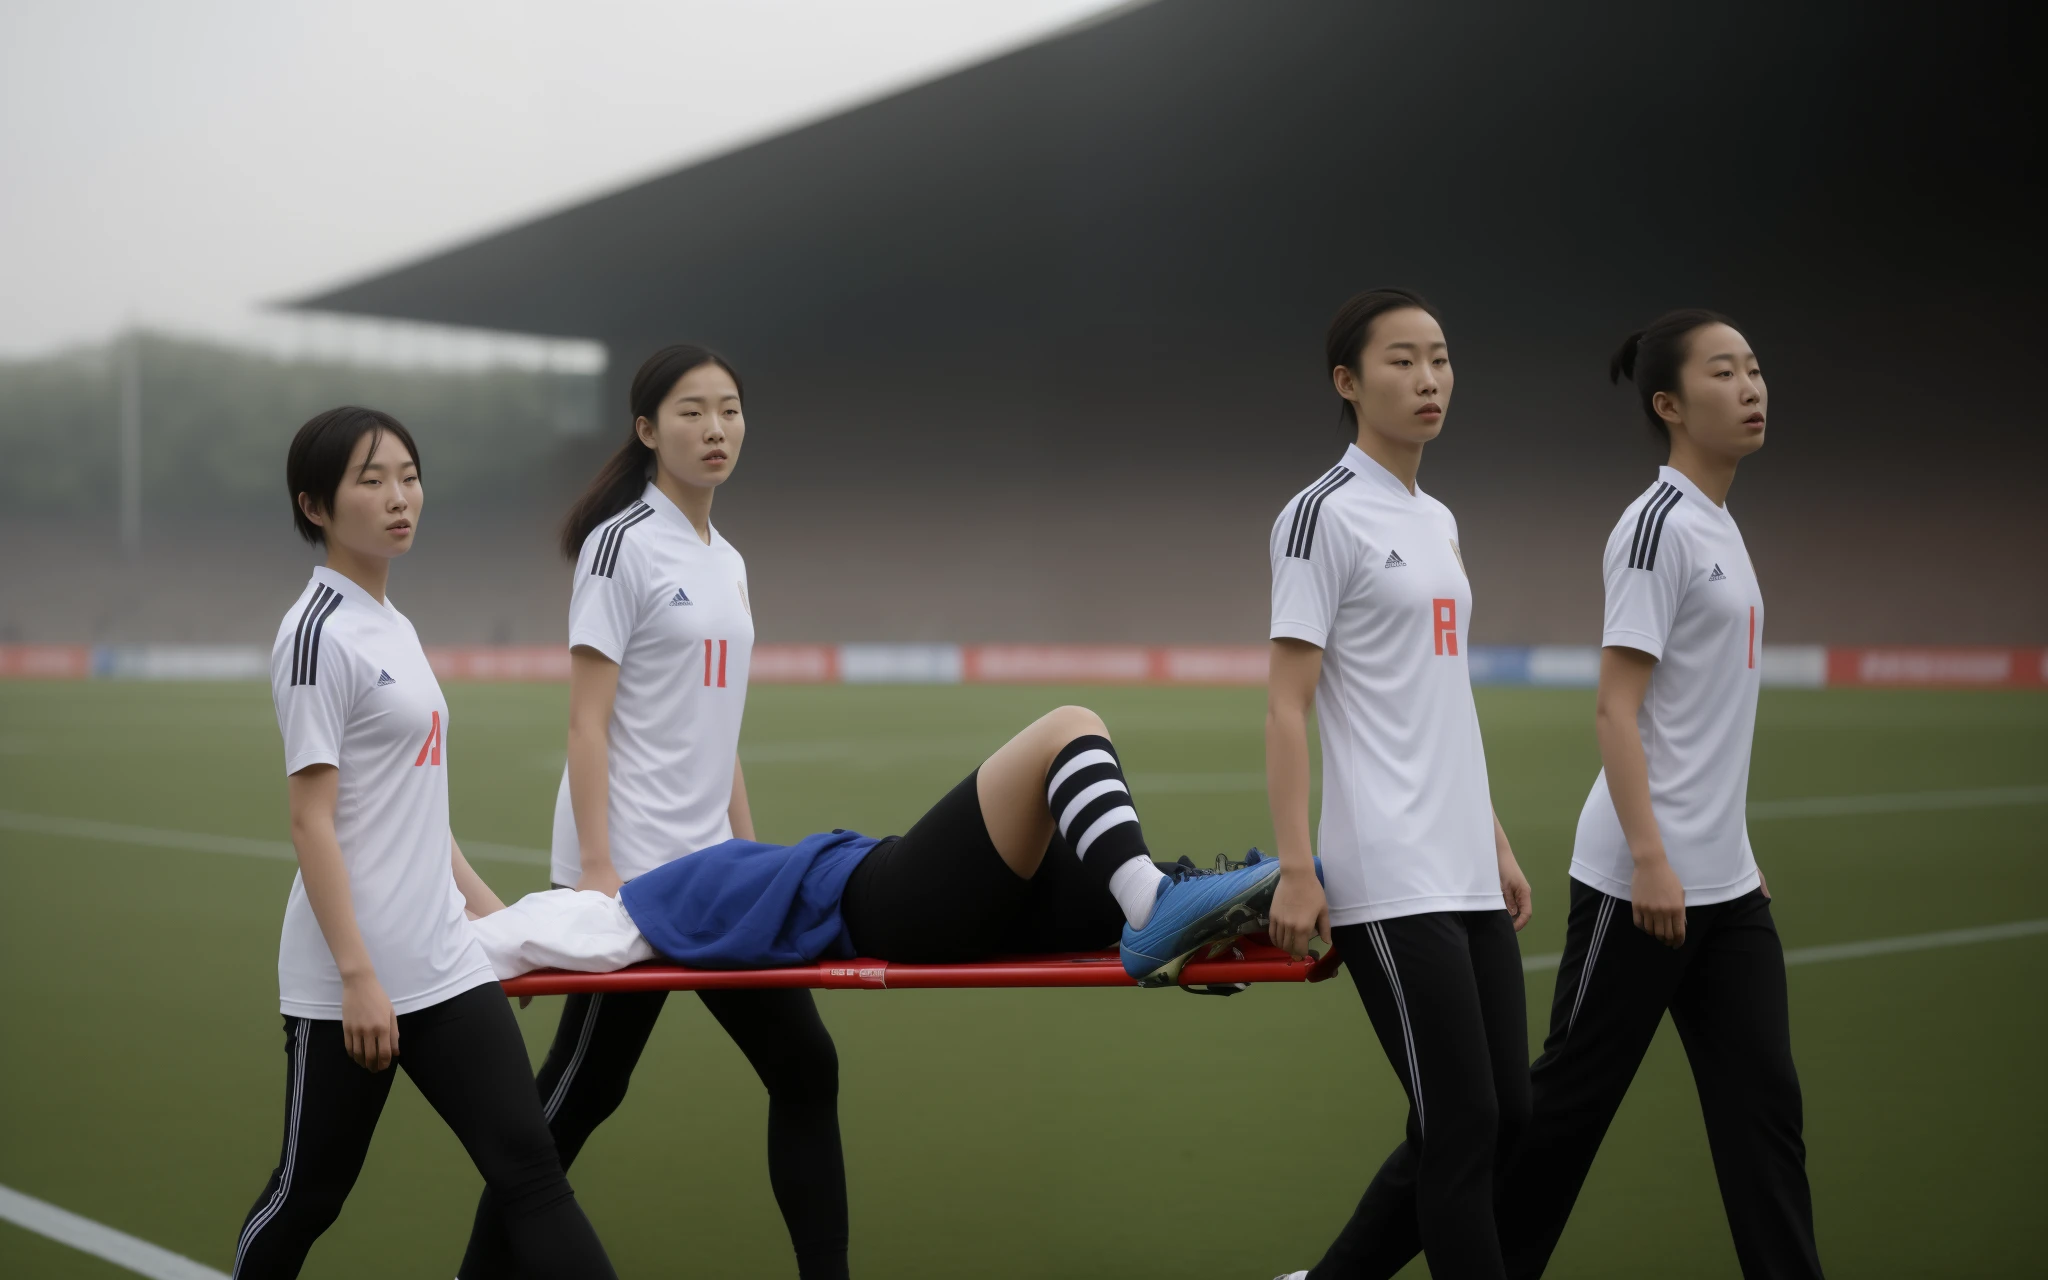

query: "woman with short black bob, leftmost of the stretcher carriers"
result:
(233, 408), (612, 1280)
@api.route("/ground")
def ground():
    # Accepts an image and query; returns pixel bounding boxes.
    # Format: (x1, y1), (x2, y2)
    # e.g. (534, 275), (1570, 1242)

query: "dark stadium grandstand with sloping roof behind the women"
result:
(280, 0), (2048, 655)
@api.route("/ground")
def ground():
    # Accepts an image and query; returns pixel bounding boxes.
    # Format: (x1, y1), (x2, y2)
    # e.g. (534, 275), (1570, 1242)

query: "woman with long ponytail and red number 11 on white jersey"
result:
(461, 344), (846, 1280)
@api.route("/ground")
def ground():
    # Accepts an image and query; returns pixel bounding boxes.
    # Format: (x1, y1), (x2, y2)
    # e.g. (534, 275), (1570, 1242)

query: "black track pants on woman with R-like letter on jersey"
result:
(1309, 911), (1530, 1280)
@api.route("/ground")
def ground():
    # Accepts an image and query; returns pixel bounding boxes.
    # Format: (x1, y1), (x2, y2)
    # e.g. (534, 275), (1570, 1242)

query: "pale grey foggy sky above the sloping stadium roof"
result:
(0, 0), (1112, 356)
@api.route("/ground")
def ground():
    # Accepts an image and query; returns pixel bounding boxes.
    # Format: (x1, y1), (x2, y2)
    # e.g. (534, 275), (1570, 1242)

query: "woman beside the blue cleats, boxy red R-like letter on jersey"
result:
(1266, 289), (1530, 1280)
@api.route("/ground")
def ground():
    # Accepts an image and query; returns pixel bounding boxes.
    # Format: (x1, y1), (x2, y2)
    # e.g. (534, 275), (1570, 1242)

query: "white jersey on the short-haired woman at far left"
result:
(270, 567), (498, 1020)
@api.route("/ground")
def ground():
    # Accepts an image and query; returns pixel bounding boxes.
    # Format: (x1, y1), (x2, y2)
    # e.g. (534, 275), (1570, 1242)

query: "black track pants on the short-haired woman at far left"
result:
(236, 983), (614, 1280)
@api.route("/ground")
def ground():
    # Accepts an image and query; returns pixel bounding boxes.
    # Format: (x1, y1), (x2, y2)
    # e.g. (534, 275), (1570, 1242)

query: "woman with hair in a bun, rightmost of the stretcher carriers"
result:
(1501, 309), (1821, 1278)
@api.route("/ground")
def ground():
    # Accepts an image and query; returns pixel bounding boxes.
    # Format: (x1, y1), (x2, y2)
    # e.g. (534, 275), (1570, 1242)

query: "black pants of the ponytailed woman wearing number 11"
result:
(461, 989), (846, 1280)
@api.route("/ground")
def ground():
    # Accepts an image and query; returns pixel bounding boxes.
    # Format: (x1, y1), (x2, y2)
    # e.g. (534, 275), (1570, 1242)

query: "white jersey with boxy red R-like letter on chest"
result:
(1272, 444), (1507, 924)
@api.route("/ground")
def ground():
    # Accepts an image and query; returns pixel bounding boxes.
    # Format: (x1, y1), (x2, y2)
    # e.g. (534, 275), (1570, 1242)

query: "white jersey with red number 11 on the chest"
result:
(553, 483), (754, 889)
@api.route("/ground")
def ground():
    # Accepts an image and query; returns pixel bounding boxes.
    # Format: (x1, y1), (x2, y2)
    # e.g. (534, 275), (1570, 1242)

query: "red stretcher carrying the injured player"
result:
(504, 934), (1339, 995)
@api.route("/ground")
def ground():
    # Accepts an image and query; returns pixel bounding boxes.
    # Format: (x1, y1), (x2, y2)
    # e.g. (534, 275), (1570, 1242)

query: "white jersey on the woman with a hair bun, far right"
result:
(1571, 467), (1763, 907)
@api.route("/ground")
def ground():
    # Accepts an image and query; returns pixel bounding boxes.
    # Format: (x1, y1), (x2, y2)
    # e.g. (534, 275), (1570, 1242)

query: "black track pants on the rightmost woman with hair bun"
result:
(1501, 881), (1821, 1280)
